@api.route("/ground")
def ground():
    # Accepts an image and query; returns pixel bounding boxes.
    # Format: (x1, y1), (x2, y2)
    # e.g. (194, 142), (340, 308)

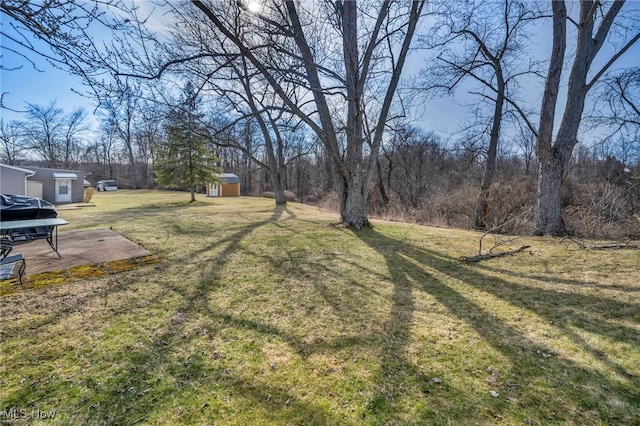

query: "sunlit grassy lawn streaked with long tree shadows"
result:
(0, 190), (640, 425)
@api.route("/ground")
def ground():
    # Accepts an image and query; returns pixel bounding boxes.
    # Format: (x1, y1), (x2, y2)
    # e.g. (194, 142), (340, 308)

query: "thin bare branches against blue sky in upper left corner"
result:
(0, 0), (136, 108)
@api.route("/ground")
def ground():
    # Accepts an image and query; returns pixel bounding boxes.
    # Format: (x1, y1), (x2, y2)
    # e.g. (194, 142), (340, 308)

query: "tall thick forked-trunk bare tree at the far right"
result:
(534, 0), (640, 235)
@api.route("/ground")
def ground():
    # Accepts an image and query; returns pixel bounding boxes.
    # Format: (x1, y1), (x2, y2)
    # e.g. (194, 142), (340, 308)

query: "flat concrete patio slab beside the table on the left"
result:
(12, 229), (151, 276)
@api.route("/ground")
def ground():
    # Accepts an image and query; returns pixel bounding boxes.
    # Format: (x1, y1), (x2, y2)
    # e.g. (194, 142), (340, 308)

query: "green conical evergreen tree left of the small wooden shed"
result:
(154, 82), (221, 202)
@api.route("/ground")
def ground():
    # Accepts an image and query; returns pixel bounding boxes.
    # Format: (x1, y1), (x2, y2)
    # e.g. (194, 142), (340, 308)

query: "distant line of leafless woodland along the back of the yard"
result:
(1, 105), (640, 238)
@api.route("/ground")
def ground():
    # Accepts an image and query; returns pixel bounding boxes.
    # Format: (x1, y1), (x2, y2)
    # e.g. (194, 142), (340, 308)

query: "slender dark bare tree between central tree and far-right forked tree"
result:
(425, 0), (540, 228)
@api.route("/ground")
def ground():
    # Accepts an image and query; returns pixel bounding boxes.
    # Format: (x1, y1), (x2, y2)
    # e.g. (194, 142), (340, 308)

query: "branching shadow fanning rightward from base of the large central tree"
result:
(356, 230), (640, 423)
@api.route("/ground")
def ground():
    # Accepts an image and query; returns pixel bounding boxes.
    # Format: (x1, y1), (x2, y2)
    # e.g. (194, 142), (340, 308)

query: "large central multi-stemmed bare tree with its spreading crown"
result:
(134, 0), (425, 228)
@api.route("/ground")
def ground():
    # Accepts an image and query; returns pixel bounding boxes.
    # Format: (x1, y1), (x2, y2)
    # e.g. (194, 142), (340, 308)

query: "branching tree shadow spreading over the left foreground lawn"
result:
(2, 207), (348, 424)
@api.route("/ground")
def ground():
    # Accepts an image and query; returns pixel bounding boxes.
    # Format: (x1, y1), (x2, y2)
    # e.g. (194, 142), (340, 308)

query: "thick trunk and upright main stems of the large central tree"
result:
(192, 0), (425, 228)
